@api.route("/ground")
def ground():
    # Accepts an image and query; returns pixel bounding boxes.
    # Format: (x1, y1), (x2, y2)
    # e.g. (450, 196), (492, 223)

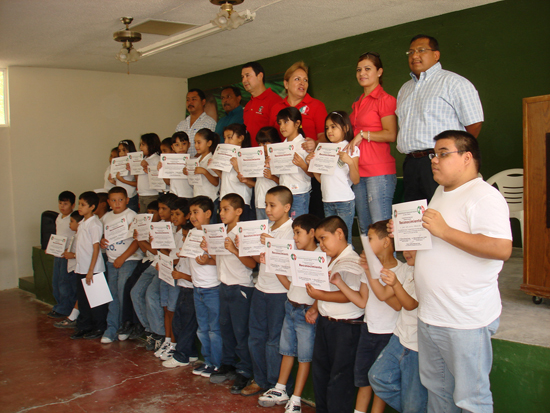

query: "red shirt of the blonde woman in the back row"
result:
(270, 93), (327, 140)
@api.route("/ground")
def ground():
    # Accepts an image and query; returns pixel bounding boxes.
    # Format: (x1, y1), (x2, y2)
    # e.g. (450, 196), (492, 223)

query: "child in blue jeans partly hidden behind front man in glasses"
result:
(369, 251), (428, 413)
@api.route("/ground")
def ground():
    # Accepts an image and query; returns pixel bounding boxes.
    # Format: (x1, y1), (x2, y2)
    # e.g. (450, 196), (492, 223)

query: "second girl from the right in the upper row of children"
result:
(277, 106), (312, 219)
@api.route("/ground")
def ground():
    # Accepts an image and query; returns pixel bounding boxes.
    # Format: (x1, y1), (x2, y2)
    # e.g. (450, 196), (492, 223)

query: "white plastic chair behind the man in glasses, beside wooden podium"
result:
(487, 168), (524, 248)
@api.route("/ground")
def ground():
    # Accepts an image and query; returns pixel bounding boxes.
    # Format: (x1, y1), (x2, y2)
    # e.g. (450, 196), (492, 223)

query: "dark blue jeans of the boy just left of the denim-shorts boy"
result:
(248, 290), (286, 389)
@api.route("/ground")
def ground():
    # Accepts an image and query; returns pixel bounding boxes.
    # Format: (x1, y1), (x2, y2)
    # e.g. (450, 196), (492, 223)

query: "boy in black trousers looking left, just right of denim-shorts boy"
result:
(306, 216), (368, 413)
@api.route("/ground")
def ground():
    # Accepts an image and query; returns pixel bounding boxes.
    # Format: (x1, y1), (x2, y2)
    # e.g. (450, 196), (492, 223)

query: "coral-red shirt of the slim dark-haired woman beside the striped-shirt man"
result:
(350, 85), (397, 177)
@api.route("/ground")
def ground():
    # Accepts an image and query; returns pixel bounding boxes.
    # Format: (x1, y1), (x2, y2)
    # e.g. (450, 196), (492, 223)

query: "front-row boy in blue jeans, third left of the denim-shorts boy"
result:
(189, 196), (222, 378)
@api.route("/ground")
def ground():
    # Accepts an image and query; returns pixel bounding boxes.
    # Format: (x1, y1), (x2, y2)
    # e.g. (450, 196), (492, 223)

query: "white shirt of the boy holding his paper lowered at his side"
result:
(75, 215), (105, 274)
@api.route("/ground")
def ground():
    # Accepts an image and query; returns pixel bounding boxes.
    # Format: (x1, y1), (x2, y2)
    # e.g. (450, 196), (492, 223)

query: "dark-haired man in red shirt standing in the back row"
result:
(241, 62), (283, 146)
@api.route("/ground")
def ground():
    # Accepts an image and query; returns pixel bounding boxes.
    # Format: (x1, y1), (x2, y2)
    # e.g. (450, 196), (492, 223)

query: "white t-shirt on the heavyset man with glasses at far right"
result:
(415, 178), (512, 329)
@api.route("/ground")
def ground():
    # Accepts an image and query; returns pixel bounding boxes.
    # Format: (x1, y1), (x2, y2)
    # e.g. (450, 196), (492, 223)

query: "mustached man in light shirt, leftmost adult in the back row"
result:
(176, 89), (216, 157)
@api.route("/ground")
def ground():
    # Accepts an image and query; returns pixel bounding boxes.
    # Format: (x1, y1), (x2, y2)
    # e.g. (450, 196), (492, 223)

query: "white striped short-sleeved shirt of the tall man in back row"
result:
(396, 62), (483, 153)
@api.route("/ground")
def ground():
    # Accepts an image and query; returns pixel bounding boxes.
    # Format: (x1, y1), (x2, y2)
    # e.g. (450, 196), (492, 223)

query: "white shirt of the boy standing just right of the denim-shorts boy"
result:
(317, 244), (365, 320)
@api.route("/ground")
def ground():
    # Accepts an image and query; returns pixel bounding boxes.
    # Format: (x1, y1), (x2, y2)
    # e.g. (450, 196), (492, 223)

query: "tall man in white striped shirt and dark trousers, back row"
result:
(396, 34), (483, 201)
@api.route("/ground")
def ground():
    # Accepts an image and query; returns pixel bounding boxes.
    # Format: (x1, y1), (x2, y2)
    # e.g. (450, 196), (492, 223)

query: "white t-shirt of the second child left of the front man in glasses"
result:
(361, 260), (413, 334)
